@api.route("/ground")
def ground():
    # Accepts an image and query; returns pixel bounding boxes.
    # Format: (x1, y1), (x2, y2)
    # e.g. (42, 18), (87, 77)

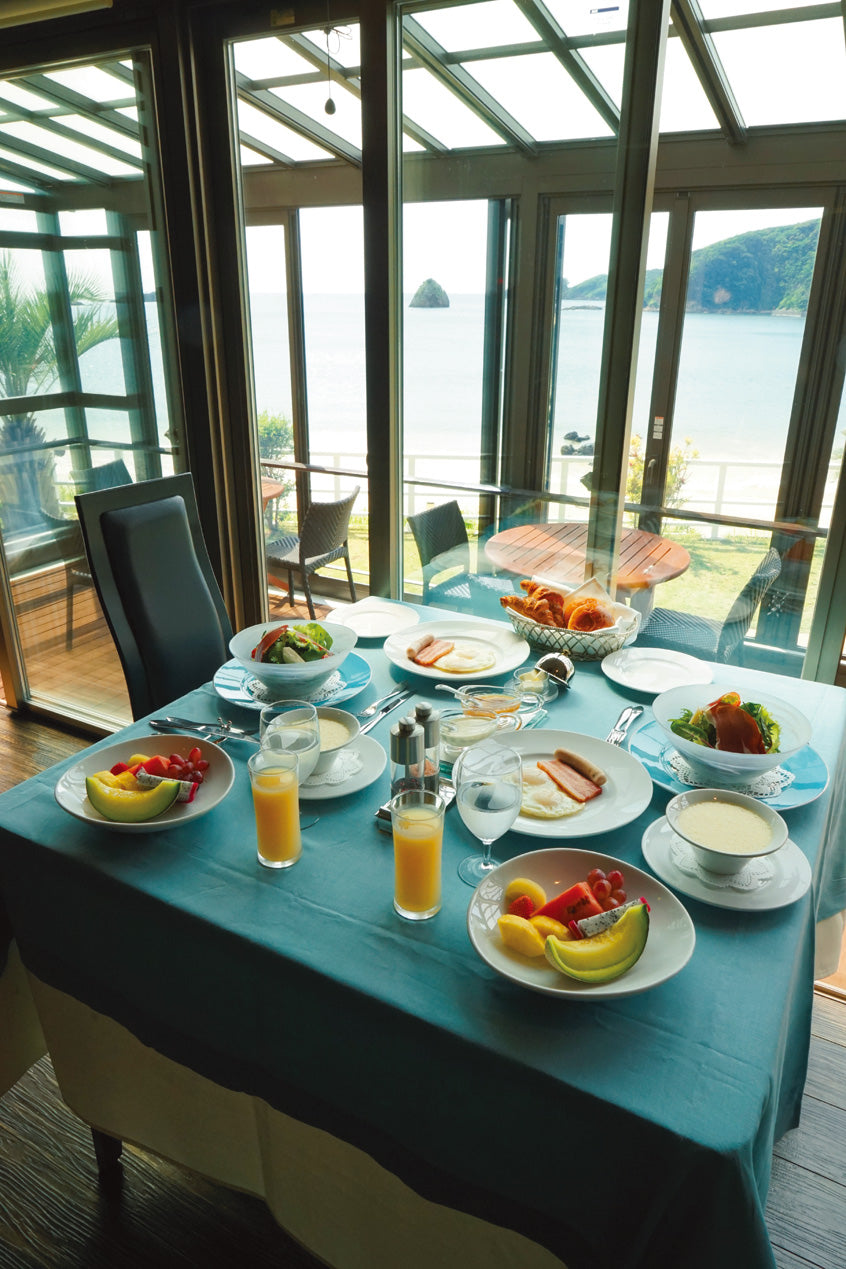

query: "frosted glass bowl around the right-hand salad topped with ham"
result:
(652, 683), (810, 786)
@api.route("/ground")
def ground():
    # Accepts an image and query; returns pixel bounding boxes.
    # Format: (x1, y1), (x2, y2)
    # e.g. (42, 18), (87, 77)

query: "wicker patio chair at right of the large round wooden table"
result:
(637, 547), (781, 665)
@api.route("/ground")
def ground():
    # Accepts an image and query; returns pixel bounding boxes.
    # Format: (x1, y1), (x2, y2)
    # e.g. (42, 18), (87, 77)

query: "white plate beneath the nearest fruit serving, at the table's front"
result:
(467, 848), (696, 1000)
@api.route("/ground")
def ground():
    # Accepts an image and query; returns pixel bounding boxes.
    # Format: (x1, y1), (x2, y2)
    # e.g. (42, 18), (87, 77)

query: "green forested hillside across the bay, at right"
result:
(564, 220), (819, 313)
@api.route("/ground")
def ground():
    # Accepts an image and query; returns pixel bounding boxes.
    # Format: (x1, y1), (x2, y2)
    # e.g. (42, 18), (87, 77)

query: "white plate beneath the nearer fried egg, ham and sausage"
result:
(497, 727), (653, 837)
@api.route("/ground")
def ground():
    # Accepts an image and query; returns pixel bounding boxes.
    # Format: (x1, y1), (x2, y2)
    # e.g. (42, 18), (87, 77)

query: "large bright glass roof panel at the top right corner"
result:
(713, 18), (846, 127)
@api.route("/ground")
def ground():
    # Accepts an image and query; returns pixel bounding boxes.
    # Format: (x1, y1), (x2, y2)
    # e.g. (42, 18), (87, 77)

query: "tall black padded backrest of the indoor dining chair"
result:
(75, 472), (232, 718)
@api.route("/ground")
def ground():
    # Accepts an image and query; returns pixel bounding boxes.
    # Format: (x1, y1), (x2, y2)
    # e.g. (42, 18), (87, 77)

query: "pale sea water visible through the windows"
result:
(76, 294), (804, 473)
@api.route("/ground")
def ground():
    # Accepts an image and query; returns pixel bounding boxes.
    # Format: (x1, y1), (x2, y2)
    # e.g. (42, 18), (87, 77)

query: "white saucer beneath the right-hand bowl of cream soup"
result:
(641, 816), (810, 912)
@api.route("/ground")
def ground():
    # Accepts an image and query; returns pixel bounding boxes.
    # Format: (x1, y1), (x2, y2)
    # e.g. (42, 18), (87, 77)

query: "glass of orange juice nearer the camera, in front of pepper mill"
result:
(391, 789), (444, 921)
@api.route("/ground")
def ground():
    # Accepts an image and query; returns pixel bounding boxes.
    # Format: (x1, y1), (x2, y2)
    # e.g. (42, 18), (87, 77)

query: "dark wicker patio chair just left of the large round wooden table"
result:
(407, 499), (514, 619)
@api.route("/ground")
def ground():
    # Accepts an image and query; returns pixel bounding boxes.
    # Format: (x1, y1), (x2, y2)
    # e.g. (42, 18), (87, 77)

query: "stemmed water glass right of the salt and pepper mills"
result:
(453, 744), (523, 886)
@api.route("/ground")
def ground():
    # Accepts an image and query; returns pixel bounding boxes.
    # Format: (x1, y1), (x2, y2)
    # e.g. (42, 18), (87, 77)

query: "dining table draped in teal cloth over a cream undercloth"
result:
(0, 605), (846, 1269)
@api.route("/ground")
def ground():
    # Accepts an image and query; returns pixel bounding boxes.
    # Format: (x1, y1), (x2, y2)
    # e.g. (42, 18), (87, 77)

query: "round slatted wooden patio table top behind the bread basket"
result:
(485, 520), (690, 607)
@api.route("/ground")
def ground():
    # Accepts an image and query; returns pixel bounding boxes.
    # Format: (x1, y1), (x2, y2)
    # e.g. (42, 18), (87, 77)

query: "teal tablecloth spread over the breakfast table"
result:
(0, 614), (846, 1269)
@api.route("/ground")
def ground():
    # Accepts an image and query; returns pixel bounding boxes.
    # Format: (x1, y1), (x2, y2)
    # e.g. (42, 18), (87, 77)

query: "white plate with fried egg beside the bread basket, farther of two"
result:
(384, 618), (529, 683)
